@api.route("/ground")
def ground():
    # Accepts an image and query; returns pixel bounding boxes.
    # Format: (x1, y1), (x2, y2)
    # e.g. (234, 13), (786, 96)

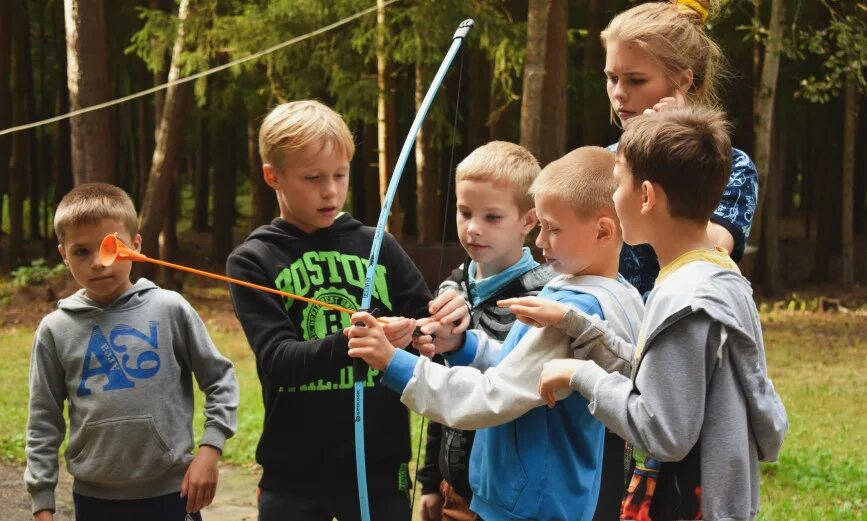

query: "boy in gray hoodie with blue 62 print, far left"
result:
(24, 183), (239, 521)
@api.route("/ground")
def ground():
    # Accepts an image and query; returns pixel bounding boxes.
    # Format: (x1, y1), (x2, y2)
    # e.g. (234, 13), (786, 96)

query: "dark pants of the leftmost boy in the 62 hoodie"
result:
(72, 492), (202, 521)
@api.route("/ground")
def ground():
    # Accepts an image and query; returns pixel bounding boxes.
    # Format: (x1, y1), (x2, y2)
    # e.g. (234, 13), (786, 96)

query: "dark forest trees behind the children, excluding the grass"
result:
(0, 0), (867, 296)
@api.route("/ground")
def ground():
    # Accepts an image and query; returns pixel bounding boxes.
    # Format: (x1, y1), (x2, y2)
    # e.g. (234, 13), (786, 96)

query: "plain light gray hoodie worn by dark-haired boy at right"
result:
(571, 262), (788, 520)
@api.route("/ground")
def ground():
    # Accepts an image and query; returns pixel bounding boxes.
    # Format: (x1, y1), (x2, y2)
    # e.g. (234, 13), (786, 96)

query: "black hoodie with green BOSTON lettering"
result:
(226, 213), (431, 490)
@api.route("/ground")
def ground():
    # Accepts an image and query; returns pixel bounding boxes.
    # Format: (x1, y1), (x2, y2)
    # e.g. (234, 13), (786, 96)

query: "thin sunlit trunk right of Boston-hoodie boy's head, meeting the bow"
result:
(376, 0), (403, 241)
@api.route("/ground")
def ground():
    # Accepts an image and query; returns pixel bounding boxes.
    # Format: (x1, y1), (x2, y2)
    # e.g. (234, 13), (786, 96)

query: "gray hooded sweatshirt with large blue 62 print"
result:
(24, 279), (239, 512)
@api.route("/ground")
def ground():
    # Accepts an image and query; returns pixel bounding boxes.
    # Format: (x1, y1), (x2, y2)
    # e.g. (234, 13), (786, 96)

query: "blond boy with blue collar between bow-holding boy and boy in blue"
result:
(417, 141), (555, 521)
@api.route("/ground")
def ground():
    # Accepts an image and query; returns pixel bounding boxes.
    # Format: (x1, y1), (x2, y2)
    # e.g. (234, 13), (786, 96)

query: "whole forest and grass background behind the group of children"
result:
(0, 0), (867, 520)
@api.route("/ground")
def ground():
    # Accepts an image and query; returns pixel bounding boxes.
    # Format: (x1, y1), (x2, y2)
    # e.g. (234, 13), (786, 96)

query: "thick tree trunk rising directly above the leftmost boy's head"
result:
(64, 0), (115, 185)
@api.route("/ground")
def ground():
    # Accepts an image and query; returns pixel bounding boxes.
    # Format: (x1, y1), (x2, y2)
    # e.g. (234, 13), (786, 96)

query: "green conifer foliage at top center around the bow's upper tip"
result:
(127, 0), (526, 146)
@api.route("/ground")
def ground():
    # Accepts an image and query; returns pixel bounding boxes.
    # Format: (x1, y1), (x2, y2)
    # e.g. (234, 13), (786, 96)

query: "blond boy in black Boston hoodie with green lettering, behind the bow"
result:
(226, 101), (431, 521)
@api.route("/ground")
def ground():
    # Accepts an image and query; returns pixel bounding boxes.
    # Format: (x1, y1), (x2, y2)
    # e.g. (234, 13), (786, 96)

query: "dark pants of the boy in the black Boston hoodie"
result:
(259, 489), (411, 521)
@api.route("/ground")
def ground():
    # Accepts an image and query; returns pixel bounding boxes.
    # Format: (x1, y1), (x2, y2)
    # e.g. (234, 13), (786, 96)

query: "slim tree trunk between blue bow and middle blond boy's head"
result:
(415, 64), (440, 244)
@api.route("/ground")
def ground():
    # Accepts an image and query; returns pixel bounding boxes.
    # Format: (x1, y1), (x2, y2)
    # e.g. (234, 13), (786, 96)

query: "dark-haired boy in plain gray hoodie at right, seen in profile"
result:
(532, 108), (788, 521)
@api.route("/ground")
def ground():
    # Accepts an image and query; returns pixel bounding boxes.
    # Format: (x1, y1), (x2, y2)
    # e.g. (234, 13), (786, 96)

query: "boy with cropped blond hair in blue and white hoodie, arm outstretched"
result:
(347, 147), (643, 521)
